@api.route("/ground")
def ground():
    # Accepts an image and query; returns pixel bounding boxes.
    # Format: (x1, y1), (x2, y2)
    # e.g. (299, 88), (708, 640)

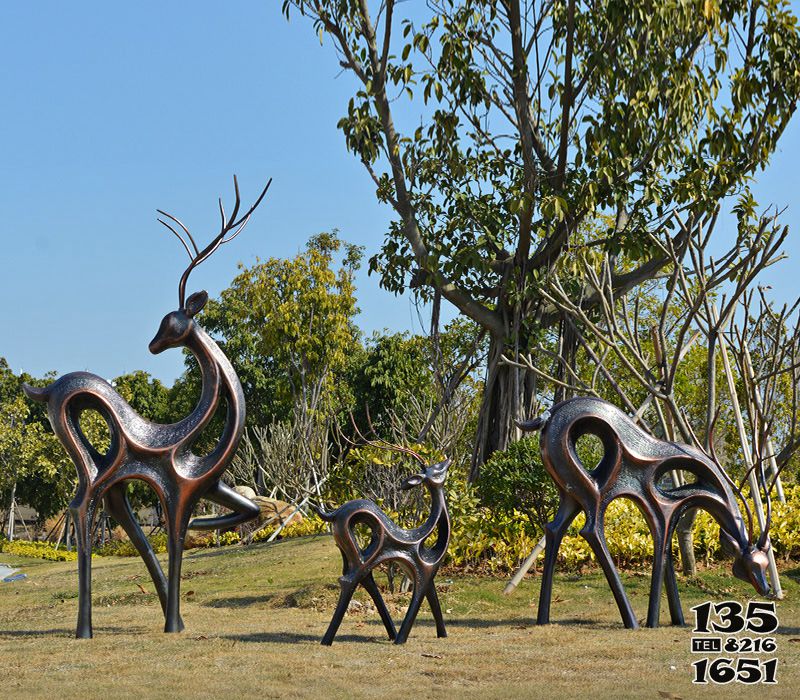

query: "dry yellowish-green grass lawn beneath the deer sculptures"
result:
(0, 536), (800, 700)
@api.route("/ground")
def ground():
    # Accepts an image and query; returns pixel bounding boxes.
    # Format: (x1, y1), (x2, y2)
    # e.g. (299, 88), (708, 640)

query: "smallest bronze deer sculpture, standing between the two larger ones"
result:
(317, 446), (450, 646)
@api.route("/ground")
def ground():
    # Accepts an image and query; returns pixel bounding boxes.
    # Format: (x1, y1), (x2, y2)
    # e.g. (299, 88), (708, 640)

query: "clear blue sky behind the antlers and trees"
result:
(0, 0), (800, 382)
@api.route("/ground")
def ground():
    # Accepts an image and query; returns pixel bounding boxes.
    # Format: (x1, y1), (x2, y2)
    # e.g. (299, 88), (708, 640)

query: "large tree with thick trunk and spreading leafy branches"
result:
(283, 0), (800, 474)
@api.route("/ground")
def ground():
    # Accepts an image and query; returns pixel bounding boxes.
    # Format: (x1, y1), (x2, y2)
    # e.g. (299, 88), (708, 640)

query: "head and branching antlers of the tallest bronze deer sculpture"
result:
(150, 175), (272, 355)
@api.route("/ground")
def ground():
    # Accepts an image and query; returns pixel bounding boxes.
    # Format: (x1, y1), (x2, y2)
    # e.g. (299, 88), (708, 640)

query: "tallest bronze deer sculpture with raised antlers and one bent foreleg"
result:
(24, 176), (271, 638)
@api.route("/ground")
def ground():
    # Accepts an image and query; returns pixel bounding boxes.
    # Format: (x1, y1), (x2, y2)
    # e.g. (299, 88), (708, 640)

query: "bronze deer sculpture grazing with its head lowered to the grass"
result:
(520, 397), (769, 629)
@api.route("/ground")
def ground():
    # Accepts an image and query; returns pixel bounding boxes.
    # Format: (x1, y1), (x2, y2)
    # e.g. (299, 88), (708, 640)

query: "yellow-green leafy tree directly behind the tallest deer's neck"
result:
(205, 231), (361, 425)
